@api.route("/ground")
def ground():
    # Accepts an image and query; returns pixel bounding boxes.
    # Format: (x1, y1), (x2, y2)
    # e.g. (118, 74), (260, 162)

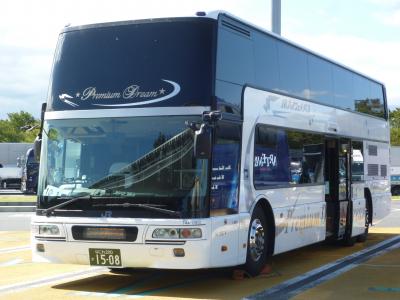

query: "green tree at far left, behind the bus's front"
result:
(0, 111), (40, 143)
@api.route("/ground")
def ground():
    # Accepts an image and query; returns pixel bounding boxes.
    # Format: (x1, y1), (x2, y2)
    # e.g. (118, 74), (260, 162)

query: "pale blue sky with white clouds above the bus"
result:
(0, 0), (400, 119)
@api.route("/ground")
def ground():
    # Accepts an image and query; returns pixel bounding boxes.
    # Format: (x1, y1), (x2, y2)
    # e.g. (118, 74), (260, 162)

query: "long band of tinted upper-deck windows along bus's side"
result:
(216, 17), (386, 118)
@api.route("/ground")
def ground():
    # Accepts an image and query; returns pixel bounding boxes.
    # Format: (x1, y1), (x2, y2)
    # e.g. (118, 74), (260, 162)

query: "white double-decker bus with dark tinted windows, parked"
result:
(32, 12), (391, 275)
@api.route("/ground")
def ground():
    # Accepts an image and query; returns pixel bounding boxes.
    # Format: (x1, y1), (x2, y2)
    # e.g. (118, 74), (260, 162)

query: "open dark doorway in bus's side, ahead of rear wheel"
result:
(325, 139), (351, 239)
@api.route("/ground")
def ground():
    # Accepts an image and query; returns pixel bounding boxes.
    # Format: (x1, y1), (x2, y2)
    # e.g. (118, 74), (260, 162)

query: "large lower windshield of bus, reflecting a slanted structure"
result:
(38, 116), (208, 218)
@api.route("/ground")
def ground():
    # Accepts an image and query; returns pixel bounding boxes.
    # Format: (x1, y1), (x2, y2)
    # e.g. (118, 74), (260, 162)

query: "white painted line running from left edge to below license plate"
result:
(0, 267), (108, 294)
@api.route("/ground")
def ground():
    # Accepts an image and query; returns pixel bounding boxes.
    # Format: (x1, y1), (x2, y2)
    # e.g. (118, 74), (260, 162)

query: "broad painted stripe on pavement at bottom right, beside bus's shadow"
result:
(244, 236), (400, 300)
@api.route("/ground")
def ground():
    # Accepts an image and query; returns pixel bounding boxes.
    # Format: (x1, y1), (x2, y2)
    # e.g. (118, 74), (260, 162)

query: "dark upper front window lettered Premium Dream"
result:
(48, 18), (215, 110)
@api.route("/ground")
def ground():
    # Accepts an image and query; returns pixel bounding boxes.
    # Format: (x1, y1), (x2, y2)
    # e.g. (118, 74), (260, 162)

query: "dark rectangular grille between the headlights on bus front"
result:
(72, 225), (138, 242)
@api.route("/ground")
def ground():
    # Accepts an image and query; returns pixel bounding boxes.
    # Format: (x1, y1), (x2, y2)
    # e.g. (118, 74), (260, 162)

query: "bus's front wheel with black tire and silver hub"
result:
(244, 206), (269, 276)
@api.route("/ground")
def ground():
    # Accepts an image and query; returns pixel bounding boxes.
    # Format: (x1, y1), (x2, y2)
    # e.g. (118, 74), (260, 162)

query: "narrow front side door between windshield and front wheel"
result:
(210, 121), (241, 267)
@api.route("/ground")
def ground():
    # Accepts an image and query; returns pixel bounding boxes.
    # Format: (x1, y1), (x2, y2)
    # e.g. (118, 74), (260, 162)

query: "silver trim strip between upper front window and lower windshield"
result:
(44, 106), (210, 120)
